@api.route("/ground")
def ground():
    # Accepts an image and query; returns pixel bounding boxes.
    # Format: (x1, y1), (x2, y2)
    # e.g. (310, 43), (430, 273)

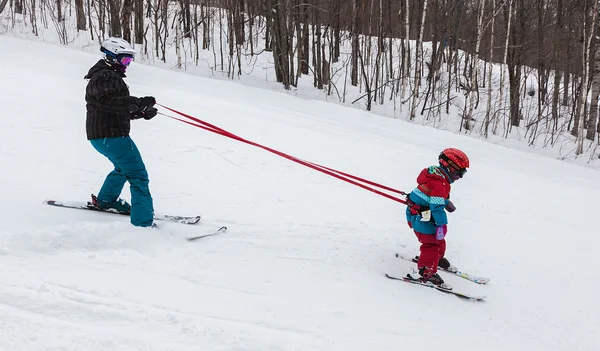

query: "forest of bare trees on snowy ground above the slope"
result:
(0, 0), (600, 160)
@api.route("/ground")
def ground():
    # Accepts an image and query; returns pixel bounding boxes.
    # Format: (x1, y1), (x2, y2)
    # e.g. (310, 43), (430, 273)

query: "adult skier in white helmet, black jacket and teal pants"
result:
(85, 38), (158, 227)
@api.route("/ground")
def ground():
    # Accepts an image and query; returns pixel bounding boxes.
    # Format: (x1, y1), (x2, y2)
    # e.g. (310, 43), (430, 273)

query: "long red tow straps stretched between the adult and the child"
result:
(157, 104), (406, 204)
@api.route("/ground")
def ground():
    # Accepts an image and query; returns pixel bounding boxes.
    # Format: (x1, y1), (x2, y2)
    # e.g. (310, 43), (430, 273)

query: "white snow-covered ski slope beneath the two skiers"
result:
(0, 36), (600, 351)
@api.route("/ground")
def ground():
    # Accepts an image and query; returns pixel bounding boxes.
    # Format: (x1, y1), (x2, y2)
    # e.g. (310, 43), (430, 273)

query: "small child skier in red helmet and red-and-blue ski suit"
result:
(406, 148), (469, 286)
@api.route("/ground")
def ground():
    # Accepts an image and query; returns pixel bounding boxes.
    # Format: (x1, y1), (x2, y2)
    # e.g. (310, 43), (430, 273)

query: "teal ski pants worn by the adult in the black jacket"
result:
(92, 137), (154, 227)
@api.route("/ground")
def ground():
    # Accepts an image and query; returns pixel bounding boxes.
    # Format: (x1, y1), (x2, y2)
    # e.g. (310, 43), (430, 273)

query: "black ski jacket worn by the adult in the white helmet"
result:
(85, 60), (138, 140)
